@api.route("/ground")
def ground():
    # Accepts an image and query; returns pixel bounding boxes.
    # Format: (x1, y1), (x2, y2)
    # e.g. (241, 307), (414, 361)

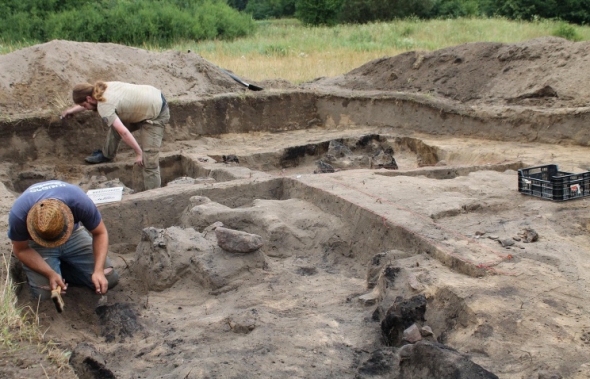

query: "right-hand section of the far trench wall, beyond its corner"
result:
(315, 94), (590, 146)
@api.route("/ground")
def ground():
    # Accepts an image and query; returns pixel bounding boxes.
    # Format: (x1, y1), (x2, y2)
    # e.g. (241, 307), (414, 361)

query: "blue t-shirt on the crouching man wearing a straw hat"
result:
(8, 180), (102, 241)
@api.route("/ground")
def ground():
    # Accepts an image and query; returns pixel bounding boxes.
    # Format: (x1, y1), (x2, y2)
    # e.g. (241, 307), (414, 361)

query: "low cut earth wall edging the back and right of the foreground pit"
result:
(99, 177), (484, 276)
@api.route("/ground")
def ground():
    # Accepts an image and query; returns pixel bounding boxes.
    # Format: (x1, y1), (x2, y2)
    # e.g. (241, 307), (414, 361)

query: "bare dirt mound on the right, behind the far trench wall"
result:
(306, 37), (590, 107)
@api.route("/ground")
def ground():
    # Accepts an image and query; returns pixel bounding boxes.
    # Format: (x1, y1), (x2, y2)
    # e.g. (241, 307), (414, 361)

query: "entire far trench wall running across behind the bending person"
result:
(0, 91), (590, 162)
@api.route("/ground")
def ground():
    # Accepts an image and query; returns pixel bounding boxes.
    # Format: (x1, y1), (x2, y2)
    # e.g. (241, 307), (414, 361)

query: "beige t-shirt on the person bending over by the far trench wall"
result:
(97, 82), (162, 126)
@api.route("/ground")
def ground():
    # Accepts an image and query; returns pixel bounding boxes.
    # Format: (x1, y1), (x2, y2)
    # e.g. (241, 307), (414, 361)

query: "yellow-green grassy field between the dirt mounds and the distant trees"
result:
(179, 18), (590, 84)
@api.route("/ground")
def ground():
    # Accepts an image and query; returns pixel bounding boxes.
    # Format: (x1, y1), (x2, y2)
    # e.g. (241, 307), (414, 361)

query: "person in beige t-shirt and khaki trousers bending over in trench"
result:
(61, 81), (170, 190)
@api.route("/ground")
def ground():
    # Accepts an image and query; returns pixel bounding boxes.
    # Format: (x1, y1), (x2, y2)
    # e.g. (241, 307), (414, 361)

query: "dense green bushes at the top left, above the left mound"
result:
(0, 0), (255, 45)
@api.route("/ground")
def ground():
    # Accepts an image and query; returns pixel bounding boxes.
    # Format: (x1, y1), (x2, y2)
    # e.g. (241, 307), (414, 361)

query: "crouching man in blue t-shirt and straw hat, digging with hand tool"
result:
(8, 180), (119, 300)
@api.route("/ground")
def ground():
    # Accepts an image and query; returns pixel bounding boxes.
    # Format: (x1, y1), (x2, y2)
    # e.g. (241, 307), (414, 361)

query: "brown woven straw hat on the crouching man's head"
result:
(27, 199), (74, 247)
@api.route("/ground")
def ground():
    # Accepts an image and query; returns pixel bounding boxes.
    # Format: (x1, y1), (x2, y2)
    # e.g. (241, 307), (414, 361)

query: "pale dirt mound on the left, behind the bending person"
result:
(0, 40), (244, 116)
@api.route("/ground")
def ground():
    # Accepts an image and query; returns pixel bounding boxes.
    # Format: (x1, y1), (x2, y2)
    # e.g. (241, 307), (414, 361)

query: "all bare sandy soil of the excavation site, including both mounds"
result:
(0, 38), (590, 379)
